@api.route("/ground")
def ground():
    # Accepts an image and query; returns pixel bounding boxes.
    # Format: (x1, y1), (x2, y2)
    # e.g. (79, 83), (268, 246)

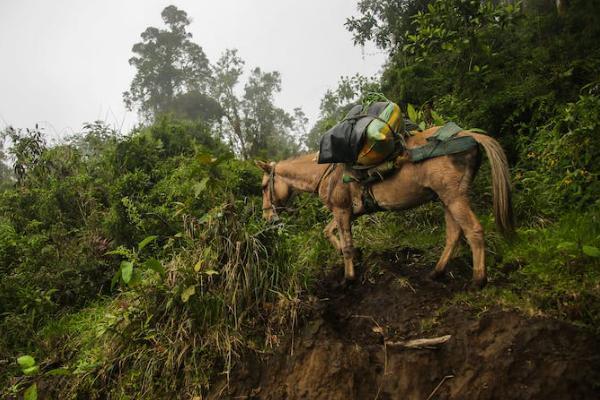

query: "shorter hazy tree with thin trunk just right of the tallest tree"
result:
(211, 50), (306, 159)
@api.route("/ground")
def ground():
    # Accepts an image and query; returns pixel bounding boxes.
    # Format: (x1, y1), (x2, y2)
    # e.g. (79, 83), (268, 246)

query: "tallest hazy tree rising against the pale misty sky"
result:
(123, 6), (210, 121)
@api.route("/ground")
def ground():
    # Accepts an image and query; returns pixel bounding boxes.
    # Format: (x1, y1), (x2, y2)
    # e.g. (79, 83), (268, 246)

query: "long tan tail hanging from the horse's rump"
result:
(463, 131), (514, 236)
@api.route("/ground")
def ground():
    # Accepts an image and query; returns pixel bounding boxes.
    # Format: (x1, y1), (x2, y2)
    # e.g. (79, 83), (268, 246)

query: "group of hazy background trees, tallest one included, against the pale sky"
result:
(123, 6), (306, 159)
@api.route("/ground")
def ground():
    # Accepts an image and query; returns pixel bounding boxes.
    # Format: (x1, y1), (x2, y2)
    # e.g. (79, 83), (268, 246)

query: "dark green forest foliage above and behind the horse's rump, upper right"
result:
(348, 0), (600, 216)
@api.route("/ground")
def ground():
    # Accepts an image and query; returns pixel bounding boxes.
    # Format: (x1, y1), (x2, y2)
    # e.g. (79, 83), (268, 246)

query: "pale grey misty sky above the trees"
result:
(0, 0), (385, 138)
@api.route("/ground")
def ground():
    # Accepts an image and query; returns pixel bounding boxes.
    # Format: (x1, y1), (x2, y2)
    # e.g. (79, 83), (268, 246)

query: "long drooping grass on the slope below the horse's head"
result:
(0, 201), (331, 398)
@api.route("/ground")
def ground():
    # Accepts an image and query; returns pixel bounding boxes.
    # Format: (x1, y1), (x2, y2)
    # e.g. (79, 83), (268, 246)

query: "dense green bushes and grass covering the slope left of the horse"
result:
(0, 117), (332, 398)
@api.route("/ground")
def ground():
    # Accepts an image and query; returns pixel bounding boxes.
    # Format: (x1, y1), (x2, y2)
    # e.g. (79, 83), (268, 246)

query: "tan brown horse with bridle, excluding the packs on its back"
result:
(257, 127), (513, 287)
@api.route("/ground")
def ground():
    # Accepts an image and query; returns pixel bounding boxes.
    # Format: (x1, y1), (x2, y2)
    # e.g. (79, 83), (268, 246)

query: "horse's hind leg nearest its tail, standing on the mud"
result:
(447, 196), (487, 288)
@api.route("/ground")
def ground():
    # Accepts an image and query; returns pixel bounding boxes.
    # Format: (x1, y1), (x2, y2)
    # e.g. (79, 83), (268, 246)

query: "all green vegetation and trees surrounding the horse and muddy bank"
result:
(0, 0), (600, 399)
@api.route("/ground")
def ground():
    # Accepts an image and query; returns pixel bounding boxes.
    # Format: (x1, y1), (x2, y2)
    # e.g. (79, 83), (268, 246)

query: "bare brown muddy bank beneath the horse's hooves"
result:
(210, 249), (600, 400)
